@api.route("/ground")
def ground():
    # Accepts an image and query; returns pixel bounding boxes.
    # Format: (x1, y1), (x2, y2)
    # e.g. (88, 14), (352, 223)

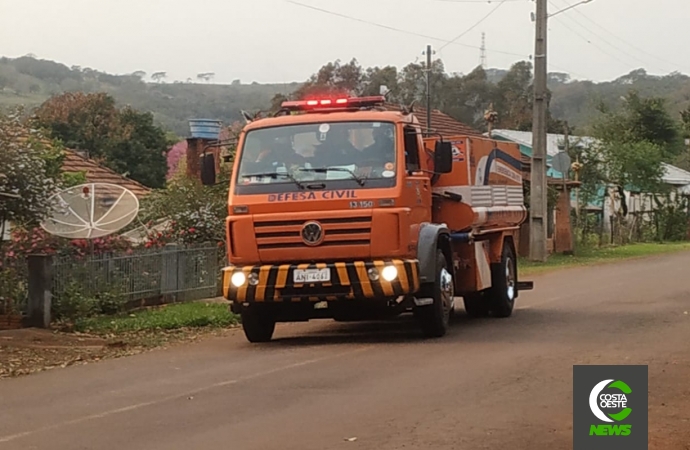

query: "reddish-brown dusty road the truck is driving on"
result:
(0, 253), (690, 450)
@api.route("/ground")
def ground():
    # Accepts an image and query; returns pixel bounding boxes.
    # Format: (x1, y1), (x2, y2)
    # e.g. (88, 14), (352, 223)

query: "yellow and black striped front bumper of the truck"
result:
(223, 260), (419, 303)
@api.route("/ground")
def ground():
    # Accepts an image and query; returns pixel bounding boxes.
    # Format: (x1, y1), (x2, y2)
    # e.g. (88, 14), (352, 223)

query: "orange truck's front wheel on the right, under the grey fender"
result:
(415, 250), (454, 338)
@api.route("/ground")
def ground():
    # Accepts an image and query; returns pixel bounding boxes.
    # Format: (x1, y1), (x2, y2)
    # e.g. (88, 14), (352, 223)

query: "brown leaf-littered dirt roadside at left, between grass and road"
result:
(0, 328), (235, 378)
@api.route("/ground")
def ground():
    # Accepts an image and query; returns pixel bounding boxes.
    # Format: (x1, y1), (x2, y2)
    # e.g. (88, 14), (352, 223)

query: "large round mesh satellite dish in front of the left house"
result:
(41, 183), (139, 239)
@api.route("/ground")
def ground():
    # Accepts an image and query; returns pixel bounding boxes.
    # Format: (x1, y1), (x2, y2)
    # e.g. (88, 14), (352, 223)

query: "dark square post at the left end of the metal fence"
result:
(27, 254), (53, 328)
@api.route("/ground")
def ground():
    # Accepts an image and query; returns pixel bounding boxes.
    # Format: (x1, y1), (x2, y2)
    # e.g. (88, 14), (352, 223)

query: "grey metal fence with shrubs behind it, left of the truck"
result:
(51, 245), (221, 312)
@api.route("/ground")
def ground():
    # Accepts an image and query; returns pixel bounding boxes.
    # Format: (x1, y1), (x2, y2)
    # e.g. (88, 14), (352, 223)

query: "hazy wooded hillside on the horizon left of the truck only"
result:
(0, 56), (299, 136)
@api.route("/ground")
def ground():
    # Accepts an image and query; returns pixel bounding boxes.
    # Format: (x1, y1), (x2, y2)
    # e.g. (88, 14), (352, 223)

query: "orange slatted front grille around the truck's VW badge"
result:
(254, 217), (371, 250)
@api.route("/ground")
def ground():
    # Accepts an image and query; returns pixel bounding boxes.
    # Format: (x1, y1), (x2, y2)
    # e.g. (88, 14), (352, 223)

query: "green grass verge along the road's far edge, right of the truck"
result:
(519, 242), (690, 275)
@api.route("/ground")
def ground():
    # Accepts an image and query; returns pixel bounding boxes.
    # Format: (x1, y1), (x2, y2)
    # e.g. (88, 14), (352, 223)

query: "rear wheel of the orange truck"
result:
(487, 241), (517, 318)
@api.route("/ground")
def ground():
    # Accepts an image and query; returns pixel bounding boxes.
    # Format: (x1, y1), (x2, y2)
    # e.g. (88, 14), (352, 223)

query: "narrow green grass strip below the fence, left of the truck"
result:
(75, 302), (239, 334)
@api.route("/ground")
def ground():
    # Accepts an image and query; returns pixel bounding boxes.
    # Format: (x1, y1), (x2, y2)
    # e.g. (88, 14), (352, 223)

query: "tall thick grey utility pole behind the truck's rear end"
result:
(529, 0), (548, 261)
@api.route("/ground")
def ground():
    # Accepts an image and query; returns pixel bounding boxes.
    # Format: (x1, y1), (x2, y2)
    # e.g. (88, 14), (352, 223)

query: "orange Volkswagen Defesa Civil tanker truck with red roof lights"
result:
(202, 97), (532, 342)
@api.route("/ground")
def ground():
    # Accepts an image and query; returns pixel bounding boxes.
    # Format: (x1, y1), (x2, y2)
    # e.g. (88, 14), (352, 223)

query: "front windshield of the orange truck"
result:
(236, 122), (397, 194)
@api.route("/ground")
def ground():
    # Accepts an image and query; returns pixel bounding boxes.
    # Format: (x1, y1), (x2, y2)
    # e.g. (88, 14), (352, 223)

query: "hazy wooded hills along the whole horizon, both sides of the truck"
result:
(0, 56), (690, 136)
